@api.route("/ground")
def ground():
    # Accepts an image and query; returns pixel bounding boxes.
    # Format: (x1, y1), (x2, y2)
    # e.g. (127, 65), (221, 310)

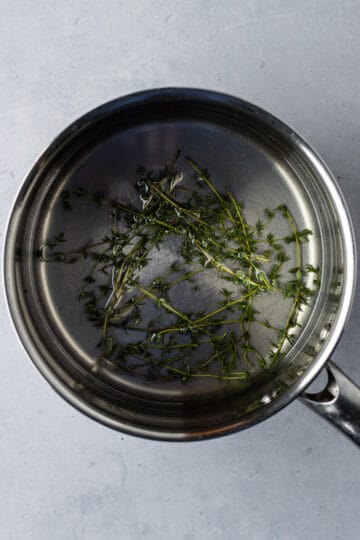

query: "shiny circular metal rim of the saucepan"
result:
(3, 88), (356, 441)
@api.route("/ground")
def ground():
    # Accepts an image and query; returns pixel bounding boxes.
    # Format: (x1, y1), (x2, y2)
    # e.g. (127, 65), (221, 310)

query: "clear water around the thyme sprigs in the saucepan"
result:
(38, 121), (321, 395)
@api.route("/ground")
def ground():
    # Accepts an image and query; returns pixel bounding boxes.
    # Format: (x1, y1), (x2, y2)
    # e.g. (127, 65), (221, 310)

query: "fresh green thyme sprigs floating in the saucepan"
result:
(37, 158), (319, 382)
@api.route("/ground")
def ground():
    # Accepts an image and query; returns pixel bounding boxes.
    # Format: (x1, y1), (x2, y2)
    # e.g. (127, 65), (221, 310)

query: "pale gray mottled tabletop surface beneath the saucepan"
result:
(0, 0), (360, 540)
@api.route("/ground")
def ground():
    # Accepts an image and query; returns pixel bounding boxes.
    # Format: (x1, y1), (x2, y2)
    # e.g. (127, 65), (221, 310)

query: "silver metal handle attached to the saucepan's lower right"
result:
(300, 360), (360, 446)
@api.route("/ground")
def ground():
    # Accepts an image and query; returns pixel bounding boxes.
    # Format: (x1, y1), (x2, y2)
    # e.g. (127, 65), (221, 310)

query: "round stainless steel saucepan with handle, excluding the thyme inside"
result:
(4, 88), (360, 444)
